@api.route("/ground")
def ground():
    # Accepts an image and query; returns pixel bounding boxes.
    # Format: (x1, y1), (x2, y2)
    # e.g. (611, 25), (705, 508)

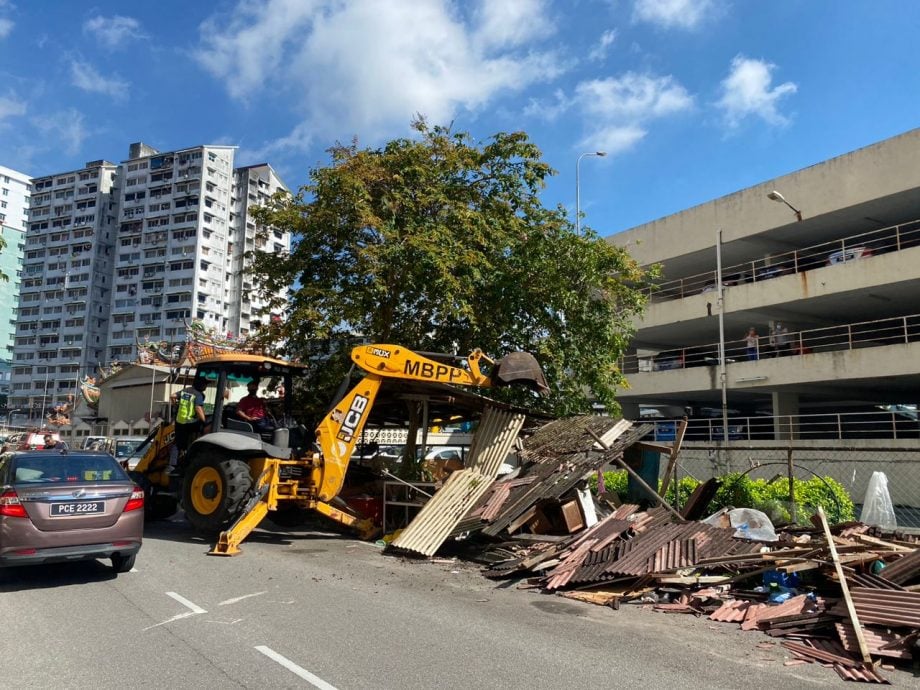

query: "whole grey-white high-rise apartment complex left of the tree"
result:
(11, 143), (290, 408)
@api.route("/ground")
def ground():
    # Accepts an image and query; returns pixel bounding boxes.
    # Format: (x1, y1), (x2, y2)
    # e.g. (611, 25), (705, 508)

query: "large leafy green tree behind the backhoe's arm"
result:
(254, 119), (652, 414)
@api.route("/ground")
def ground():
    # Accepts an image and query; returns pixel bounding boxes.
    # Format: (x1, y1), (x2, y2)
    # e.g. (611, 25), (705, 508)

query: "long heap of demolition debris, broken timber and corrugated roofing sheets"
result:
(391, 417), (920, 683)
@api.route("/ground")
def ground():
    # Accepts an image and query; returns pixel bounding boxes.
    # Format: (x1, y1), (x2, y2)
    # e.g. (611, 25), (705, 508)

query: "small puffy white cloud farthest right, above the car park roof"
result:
(716, 55), (798, 128)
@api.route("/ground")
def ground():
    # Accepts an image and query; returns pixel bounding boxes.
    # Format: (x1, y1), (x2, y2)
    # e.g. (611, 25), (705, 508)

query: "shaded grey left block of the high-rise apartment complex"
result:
(9, 160), (118, 409)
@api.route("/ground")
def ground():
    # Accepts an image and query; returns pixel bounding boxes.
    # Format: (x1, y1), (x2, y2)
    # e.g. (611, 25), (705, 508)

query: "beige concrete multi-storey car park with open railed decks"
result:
(610, 129), (920, 440)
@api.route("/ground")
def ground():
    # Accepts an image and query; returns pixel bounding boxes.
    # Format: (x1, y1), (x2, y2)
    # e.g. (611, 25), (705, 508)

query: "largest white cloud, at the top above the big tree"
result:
(196, 0), (567, 153)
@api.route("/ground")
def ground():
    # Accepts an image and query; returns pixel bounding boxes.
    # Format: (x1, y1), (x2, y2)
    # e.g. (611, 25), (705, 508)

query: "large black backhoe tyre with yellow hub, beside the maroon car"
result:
(182, 449), (253, 536)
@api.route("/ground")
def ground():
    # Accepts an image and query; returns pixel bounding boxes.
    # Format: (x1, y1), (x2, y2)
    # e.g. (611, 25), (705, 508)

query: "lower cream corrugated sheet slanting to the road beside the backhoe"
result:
(390, 470), (492, 556)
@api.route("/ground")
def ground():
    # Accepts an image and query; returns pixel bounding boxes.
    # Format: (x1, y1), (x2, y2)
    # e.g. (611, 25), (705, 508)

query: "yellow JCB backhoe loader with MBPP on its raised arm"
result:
(132, 345), (547, 556)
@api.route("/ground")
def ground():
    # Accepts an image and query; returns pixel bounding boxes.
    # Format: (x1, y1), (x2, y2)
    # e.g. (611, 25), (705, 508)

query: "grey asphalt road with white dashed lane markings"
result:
(0, 521), (920, 690)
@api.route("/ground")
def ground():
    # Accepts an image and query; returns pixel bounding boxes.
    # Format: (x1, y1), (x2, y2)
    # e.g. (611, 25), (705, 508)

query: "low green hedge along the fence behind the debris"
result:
(588, 470), (856, 524)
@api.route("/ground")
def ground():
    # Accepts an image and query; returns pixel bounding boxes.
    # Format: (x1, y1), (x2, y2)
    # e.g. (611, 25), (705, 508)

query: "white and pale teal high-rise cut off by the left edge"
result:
(0, 165), (32, 395)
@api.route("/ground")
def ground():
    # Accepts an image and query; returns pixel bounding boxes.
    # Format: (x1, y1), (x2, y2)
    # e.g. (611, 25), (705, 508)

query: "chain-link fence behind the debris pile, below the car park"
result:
(662, 443), (920, 530)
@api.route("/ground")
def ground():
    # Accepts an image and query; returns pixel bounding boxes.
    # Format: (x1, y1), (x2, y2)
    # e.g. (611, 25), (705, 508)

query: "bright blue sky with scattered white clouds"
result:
(0, 0), (920, 235)
